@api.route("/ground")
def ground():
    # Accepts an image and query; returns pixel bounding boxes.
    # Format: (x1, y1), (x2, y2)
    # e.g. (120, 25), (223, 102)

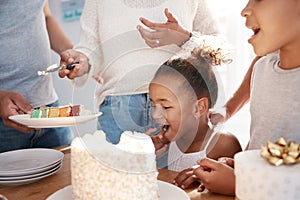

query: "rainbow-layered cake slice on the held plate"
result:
(31, 105), (81, 118)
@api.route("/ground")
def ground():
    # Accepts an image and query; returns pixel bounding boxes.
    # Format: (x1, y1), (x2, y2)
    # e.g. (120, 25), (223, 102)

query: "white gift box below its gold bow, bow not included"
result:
(234, 150), (300, 200)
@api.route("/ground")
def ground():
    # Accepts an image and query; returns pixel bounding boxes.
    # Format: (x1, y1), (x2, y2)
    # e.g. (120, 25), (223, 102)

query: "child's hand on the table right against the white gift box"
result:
(194, 158), (235, 195)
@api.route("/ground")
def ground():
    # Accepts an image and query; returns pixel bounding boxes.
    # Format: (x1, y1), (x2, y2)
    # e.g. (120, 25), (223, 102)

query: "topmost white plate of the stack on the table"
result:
(0, 148), (64, 176)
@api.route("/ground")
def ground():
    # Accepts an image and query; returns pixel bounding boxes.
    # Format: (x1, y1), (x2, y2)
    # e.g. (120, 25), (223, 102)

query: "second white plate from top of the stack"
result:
(0, 162), (62, 186)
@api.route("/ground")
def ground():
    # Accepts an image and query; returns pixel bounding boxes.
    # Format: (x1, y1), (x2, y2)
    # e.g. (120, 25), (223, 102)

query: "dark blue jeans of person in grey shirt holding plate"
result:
(0, 101), (74, 153)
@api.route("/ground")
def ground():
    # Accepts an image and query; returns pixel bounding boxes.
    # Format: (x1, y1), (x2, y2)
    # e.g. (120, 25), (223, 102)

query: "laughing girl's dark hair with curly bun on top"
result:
(154, 35), (232, 108)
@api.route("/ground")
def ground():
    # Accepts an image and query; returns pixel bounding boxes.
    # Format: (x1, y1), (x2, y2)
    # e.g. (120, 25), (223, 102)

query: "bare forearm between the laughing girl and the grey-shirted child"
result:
(225, 56), (260, 120)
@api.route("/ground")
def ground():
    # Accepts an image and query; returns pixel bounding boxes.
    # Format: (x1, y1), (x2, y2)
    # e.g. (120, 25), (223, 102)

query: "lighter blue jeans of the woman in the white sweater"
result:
(98, 93), (156, 144)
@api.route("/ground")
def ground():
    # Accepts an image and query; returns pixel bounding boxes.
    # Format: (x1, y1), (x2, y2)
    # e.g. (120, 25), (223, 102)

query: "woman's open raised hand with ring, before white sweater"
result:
(137, 8), (190, 48)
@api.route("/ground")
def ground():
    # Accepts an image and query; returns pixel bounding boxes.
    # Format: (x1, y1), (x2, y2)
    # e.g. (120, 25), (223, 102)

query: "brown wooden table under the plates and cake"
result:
(0, 147), (235, 200)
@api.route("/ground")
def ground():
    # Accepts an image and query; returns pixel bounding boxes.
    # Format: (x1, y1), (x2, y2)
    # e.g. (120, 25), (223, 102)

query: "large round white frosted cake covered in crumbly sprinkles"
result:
(71, 131), (159, 200)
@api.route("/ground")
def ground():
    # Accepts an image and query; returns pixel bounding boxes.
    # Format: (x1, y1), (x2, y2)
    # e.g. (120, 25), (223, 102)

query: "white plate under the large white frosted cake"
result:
(47, 181), (190, 200)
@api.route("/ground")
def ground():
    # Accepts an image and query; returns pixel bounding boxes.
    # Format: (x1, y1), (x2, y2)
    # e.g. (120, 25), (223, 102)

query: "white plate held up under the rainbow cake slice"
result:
(9, 112), (102, 128)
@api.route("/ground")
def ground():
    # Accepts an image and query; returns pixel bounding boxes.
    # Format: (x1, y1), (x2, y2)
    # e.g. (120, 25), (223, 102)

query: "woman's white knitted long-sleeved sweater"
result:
(75, 0), (218, 105)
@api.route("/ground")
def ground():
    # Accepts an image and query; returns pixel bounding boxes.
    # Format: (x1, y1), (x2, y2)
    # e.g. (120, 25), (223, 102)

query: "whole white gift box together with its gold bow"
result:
(234, 138), (300, 200)
